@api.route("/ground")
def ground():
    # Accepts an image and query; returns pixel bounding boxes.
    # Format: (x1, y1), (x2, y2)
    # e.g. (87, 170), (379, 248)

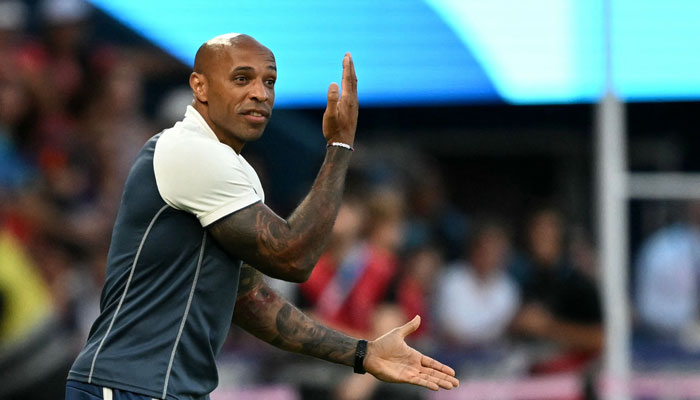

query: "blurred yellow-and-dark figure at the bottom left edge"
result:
(0, 225), (73, 400)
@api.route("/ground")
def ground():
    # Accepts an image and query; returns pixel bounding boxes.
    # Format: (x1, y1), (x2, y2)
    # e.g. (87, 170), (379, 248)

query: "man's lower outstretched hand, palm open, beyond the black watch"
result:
(364, 315), (459, 390)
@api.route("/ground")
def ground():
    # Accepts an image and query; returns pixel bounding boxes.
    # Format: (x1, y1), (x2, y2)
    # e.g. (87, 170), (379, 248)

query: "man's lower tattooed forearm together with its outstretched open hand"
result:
(234, 265), (459, 390)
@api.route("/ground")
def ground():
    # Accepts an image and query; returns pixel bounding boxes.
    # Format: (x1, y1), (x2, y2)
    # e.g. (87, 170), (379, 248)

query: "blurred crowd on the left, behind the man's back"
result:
(0, 0), (187, 398)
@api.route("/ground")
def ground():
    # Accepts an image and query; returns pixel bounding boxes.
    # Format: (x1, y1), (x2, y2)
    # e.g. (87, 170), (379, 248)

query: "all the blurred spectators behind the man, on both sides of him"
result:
(0, 0), (700, 399)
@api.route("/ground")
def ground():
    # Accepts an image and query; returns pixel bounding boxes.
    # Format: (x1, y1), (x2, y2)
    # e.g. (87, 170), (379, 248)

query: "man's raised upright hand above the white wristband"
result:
(323, 53), (358, 146)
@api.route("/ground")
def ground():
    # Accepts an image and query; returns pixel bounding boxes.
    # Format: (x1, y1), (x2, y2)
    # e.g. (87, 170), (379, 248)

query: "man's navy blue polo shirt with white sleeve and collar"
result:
(68, 107), (264, 399)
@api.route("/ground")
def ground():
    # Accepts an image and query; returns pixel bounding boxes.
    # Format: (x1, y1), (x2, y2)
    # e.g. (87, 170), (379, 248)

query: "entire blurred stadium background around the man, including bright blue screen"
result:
(0, 0), (700, 400)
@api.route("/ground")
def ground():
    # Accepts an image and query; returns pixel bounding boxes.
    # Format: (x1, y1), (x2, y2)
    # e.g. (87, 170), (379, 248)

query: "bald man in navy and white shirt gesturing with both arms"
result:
(66, 34), (459, 400)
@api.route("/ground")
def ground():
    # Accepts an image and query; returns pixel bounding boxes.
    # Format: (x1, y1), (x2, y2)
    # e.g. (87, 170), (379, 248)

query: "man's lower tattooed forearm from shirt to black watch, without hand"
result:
(234, 267), (357, 366)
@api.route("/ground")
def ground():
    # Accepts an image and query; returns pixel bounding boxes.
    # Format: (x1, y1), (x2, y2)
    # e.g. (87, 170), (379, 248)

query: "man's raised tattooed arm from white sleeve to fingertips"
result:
(209, 54), (358, 282)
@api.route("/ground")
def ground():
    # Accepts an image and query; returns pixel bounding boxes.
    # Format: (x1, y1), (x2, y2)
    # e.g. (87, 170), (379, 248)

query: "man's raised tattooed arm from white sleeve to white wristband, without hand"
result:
(209, 147), (350, 281)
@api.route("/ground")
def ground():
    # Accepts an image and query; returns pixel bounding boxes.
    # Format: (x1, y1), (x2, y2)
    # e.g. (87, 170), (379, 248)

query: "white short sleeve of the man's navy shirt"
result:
(153, 135), (261, 226)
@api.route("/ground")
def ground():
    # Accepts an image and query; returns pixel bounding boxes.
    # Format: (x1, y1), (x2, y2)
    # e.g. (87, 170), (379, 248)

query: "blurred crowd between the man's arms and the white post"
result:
(237, 158), (603, 399)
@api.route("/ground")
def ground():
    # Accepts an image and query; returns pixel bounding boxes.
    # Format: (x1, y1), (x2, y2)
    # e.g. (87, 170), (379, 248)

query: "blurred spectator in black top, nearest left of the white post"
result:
(513, 208), (603, 372)
